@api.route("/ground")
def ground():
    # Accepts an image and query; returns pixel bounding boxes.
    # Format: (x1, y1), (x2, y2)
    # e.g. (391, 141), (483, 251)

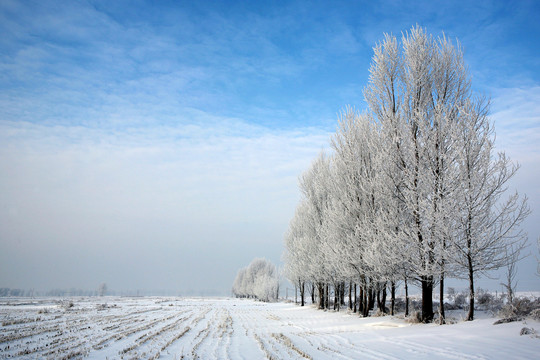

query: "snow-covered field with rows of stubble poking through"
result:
(0, 297), (540, 359)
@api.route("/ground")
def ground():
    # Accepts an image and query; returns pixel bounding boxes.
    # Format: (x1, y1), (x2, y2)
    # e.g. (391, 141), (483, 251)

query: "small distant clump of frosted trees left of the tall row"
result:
(232, 258), (279, 302)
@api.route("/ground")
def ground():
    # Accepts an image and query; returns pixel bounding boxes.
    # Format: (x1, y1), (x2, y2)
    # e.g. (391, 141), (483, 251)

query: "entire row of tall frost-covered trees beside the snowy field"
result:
(284, 27), (529, 322)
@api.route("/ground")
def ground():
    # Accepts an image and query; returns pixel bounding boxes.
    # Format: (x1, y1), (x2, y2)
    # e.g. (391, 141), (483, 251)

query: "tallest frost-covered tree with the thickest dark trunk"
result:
(364, 27), (468, 321)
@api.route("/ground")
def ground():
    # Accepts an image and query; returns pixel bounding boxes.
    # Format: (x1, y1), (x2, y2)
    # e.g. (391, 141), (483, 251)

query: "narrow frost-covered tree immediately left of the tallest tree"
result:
(327, 108), (388, 315)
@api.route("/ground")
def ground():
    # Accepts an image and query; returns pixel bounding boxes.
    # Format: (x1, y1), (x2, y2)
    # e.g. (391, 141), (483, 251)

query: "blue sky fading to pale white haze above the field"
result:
(0, 0), (540, 294)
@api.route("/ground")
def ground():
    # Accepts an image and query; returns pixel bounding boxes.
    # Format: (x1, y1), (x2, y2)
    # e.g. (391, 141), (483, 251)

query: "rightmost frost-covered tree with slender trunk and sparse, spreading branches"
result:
(454, 99), (530, 320)
